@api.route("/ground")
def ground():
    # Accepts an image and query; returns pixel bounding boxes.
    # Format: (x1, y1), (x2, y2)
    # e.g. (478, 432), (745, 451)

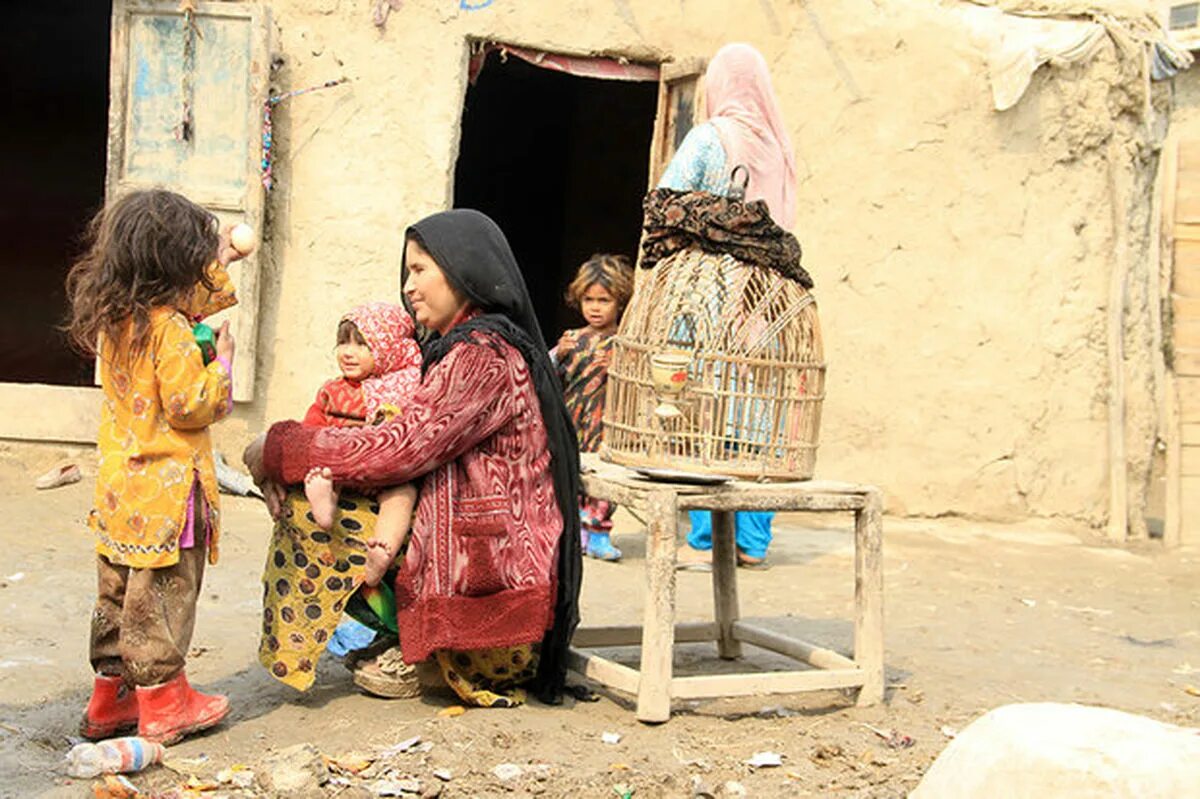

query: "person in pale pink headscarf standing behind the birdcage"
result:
(659, 43), (796, 569)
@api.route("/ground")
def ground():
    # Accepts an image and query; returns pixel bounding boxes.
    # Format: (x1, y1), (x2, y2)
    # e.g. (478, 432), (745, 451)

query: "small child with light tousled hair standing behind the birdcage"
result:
(551, 254), (634, 560)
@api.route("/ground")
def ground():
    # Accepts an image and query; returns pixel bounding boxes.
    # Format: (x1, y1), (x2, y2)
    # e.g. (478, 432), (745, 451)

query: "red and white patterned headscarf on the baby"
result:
(342, 302), (421, 422)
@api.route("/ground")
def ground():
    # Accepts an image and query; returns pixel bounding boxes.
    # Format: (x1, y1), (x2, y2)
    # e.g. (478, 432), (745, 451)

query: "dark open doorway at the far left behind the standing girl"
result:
(0, 0), (112, 385)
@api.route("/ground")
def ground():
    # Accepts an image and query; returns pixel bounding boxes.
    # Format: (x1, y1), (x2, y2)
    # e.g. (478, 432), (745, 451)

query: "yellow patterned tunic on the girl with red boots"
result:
(88, 272), (232, 569)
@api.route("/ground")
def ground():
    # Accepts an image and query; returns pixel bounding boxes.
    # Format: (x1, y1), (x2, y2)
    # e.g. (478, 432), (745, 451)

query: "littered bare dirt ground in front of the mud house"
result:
(0, 453), (1200, 799)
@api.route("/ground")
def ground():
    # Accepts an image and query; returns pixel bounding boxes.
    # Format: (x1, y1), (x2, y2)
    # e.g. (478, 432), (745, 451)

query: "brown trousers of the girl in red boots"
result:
(91, 542), (208, 685)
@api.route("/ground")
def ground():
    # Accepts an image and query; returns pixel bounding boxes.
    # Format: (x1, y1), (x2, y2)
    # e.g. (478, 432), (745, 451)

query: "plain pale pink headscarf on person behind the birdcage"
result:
(704, 44), (796, 229)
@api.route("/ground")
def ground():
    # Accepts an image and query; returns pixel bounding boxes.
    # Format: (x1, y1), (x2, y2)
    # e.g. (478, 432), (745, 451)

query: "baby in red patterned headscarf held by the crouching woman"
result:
(304, 302), (421, 587)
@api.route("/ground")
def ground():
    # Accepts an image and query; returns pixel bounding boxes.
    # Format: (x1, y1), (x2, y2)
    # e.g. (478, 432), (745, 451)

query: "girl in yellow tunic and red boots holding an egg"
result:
(67, 190), (239, 743)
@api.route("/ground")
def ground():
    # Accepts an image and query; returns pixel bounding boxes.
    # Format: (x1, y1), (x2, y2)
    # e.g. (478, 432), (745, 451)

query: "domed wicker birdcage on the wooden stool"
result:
(602, 247), (826, 480)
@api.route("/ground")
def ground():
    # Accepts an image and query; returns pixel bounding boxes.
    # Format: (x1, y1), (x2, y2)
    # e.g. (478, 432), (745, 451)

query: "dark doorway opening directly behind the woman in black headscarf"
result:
(455, 53), (658, 346)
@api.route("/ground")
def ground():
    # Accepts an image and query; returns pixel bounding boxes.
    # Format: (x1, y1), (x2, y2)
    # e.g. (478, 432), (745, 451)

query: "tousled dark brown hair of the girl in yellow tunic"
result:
(64, 188), (218, 358)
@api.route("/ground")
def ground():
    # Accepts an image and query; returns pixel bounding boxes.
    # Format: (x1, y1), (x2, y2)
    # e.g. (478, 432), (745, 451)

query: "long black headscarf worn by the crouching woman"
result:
(403, 209), (583, 704)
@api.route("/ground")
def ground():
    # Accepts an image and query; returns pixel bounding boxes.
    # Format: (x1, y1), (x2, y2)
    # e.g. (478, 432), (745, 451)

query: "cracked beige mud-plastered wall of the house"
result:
(216, 0), (1165, 525)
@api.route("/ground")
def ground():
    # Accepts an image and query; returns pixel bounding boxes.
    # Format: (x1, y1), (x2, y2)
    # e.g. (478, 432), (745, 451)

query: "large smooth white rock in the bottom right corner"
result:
(910, 702), (1200, 799)
